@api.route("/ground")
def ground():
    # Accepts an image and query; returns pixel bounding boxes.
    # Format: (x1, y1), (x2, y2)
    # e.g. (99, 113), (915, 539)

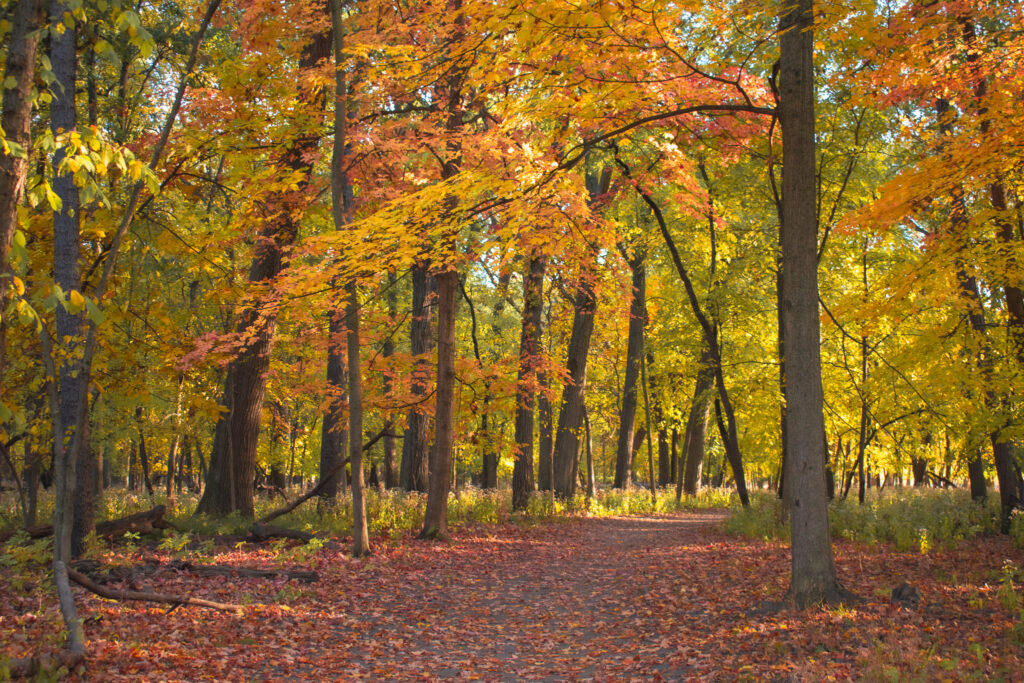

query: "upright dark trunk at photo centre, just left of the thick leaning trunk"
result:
(512, 256), (546, 510)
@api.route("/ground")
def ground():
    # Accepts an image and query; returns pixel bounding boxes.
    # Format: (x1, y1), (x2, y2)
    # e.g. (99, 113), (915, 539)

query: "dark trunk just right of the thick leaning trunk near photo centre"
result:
(612, 252), (647, 488)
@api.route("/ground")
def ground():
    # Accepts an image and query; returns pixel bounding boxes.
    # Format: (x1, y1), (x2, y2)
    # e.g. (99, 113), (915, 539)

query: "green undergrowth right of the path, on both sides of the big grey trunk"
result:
(725, 488), (1003, 553)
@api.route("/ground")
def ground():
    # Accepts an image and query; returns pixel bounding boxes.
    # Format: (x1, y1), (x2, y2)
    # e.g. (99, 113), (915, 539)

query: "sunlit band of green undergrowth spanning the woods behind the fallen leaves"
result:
(0, 486), (1007, 552)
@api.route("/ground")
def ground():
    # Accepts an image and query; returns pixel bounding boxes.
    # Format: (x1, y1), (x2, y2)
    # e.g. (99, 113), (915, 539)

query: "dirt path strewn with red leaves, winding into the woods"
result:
(323, 515), (733, 680)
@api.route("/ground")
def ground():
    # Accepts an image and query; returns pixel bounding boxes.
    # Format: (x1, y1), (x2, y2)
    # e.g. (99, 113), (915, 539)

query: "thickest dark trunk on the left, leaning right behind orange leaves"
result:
(196, 33), (331, 517)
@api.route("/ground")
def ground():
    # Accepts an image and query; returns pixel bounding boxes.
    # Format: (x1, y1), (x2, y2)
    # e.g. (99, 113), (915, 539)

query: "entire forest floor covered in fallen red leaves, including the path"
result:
(0, 512), (1024, 681)
